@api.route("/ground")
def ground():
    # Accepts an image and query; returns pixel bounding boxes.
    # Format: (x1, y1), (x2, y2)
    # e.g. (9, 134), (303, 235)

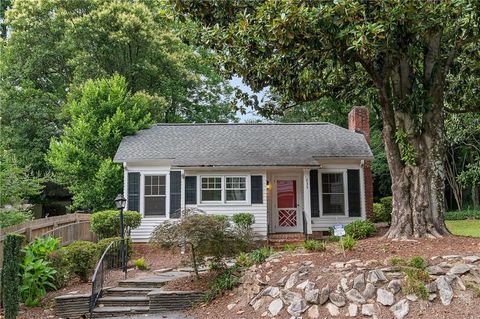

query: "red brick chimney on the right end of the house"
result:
(348, 106), (373, 220)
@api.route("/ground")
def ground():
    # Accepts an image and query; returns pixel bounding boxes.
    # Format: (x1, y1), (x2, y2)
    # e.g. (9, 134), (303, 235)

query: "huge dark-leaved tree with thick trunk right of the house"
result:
(174, 0), (480, 238)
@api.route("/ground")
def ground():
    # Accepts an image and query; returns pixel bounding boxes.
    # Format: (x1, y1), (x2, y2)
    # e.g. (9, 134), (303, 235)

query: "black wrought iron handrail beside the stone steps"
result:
(90, 239), (128, 318)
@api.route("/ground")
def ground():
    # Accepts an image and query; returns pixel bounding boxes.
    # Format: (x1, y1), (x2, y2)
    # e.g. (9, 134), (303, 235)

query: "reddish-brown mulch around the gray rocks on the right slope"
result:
(189, 236), (480, 319)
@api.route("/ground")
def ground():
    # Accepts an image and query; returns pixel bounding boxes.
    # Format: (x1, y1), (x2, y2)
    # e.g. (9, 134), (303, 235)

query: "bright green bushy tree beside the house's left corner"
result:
(46, 75), (153, 210)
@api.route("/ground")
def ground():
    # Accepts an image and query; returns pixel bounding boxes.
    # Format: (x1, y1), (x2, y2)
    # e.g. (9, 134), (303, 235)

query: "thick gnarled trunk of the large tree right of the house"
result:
(380, 89), (449, 239)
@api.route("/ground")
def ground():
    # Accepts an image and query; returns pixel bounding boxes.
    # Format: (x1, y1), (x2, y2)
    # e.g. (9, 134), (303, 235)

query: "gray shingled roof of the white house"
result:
(114, 123), (373, 167)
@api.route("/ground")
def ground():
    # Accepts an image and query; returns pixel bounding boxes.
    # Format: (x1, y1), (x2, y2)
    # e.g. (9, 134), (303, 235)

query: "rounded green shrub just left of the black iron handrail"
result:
(65, 241), (98, 282)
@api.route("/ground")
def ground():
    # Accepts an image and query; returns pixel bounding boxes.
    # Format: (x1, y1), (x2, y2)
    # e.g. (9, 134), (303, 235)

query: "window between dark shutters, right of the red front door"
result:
(322, 173), (345, 215)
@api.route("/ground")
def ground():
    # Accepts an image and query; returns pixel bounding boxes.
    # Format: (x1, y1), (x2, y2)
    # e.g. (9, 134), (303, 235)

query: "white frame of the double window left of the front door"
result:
(196, 173), (251, 206)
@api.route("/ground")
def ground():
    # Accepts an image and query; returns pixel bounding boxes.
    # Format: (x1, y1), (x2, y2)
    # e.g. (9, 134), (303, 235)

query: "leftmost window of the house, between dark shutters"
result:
(144, 175), (166, 216)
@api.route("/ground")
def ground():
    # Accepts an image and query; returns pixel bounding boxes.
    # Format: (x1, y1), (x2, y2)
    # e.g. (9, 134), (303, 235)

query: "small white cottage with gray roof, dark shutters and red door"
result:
(114, 107), (373, 242)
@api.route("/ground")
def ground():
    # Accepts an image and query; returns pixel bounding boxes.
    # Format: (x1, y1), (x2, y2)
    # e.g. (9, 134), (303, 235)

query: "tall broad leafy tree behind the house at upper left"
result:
(0, 0), (235, 172)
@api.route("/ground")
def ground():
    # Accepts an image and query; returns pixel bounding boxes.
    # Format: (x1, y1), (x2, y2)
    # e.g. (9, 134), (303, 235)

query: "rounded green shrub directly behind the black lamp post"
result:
(90, 210), (142, 238)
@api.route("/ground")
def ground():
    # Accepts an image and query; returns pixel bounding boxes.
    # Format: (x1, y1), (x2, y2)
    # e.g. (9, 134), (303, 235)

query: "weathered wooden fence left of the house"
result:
(0, 213), (96, 267)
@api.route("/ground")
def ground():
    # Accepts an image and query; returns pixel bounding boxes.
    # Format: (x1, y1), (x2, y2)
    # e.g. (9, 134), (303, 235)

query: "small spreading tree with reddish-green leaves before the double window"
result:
(150, 209), (251, 277)
